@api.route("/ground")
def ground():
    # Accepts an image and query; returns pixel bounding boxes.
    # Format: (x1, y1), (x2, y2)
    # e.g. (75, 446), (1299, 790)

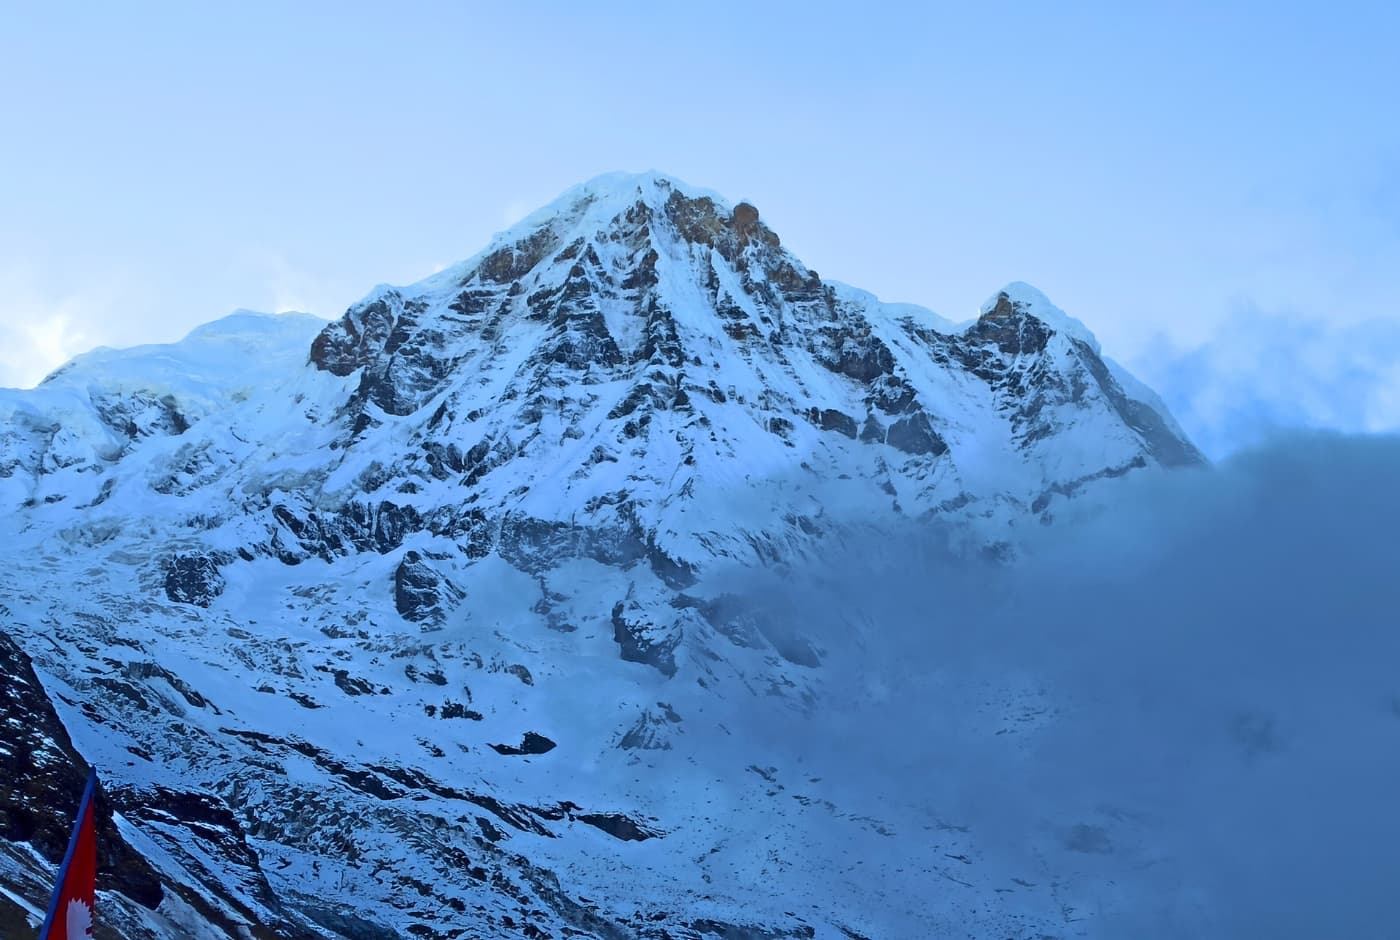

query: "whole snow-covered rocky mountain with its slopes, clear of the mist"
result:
(0, 174), (1201, 940)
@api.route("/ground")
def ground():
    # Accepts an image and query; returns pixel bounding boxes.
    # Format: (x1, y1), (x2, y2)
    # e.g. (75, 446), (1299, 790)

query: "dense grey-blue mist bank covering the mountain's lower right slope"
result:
(736, 434), (1400, 937)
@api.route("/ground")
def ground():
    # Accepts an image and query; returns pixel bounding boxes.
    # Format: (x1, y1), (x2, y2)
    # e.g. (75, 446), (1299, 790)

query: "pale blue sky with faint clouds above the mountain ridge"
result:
(0, 0), (1400, 448)
